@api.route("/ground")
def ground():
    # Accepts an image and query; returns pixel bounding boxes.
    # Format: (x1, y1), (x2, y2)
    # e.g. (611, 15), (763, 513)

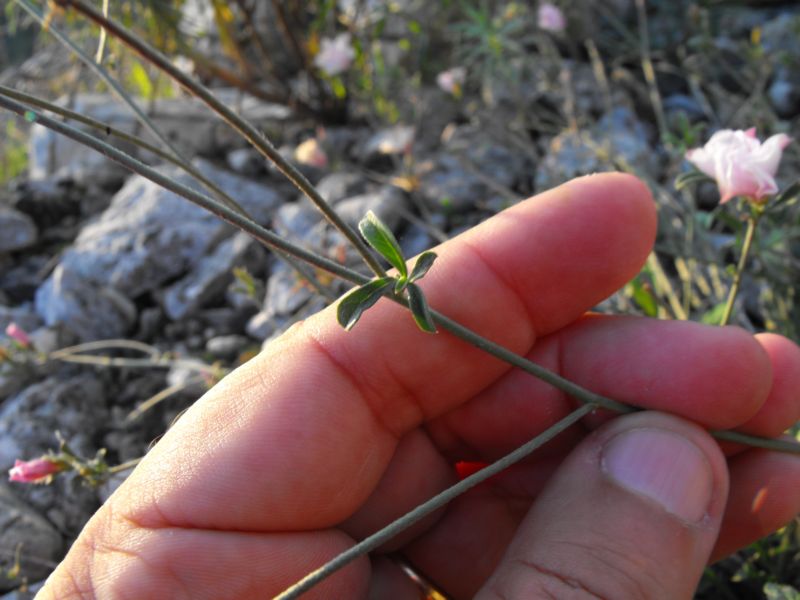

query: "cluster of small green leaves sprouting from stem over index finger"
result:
(336, 211), (436, 333)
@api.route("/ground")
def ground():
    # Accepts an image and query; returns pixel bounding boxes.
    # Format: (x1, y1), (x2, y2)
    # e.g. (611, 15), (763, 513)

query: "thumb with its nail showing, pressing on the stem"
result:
(477, 412), (728, 600)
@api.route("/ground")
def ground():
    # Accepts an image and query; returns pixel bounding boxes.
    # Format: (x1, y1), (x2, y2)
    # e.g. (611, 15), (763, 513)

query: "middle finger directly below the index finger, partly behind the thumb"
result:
(427, 315), (772, 461)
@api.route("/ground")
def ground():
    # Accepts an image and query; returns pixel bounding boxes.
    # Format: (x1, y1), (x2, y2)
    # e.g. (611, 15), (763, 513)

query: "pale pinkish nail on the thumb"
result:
(602, 429), (714, 523)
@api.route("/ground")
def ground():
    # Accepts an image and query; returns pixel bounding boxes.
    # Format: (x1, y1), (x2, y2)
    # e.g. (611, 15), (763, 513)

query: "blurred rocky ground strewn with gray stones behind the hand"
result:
(0, 0), (800, 599)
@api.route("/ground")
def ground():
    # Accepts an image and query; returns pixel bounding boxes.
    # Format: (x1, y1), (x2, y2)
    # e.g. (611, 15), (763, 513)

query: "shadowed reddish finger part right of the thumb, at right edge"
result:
(712, 449), (800, 561)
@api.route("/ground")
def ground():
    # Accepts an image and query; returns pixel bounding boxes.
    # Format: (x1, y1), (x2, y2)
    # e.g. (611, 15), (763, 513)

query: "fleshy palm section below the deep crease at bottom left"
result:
(37, 504), (371, 600)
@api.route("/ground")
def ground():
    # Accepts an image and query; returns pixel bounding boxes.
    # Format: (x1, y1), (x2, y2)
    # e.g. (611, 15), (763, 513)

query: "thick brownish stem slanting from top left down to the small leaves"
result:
(53, 0), (386, 277)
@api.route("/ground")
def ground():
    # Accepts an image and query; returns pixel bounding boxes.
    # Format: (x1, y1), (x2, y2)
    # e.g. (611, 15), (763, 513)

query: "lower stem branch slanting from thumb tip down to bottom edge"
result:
(274, 404), (597, 600)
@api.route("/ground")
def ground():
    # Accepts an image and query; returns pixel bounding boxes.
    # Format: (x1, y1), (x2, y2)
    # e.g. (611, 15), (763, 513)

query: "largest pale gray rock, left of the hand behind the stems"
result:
(36, 161), (280, 341)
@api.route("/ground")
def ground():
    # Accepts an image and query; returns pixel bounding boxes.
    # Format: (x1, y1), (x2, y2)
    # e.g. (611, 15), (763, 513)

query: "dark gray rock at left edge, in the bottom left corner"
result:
(0, 482), (64, 598)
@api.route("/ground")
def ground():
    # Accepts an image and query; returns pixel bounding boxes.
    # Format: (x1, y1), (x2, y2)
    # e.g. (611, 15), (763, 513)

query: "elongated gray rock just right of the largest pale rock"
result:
(164, 232), (264, 321)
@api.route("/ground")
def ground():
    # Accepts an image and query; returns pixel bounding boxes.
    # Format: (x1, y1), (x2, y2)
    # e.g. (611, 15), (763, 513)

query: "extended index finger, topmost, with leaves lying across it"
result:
(117, 175), (655, 530)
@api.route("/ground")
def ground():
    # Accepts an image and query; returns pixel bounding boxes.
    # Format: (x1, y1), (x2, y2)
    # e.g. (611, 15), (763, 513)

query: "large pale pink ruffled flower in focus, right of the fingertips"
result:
(686, 127), (792, 202)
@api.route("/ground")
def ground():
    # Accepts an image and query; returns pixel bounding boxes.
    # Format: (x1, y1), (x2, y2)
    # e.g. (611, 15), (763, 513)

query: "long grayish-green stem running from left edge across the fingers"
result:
(0, 96), (800, 454)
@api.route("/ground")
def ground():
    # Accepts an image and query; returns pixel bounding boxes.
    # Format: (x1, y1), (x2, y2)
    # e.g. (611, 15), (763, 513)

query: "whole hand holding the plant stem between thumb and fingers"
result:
(39, 174), (800, 599)
